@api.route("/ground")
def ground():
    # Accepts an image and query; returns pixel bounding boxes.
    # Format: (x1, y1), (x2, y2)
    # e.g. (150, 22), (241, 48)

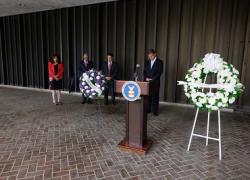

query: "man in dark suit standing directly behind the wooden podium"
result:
(144, 49), (163, 116)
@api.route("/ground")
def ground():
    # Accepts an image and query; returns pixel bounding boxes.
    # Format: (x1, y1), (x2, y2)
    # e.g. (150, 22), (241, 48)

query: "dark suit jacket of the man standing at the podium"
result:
(144, 58), (163, 87)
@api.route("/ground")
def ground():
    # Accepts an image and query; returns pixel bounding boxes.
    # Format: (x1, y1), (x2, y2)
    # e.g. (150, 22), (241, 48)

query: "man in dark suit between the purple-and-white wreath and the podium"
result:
(102, 53), (118, 104)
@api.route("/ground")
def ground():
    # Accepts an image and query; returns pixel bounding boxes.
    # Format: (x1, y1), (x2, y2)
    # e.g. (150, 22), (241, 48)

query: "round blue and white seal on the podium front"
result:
(122, 81), (141, 101)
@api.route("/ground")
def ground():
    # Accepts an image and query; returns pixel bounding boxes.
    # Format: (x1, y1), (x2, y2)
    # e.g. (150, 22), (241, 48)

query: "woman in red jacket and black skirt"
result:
(48, 55), (63, 105)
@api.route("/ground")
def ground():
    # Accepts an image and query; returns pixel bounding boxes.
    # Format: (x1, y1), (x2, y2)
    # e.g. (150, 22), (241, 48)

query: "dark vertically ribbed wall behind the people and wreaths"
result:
(0, 0), (250, 107)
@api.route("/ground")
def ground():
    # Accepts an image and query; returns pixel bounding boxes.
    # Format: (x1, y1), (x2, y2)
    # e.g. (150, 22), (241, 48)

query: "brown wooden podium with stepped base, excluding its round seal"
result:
(115, 80), (152, 154)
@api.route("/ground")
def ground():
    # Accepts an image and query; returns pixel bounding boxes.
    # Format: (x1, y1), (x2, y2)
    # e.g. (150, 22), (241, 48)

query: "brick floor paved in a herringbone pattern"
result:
(0, 88), (250, 180)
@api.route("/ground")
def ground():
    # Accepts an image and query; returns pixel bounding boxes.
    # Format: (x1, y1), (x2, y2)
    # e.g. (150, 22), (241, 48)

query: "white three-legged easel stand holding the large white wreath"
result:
(187, 76), (221, 160)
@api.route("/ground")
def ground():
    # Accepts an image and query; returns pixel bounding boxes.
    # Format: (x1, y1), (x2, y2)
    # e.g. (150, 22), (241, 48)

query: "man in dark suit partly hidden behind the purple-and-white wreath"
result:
(78, 53), (94, 104)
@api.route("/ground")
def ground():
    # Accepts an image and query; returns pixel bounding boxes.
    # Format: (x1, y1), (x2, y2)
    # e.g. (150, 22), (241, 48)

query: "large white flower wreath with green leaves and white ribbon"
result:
(178, 53), (244, 111)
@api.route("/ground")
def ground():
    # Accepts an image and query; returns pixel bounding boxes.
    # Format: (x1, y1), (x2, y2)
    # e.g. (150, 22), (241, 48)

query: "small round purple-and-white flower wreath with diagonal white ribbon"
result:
(79, 69), (106, 99)
